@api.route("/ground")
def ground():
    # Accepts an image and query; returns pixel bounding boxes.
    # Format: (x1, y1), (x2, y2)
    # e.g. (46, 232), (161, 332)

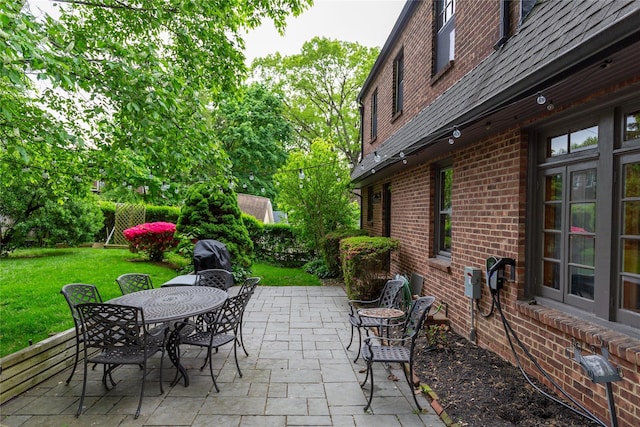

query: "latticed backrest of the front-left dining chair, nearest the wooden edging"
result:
(77, 303), (146, 350)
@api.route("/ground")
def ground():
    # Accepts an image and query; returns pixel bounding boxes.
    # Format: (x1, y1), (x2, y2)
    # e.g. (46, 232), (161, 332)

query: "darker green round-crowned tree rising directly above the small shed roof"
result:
(214, 83), (291, 204)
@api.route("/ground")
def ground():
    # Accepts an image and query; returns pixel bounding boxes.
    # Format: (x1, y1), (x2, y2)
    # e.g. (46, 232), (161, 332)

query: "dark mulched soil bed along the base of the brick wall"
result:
(412, 331), (608, 427)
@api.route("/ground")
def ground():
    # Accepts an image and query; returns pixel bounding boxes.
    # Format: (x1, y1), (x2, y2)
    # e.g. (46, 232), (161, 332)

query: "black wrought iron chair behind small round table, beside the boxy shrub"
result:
(347, 279), (404, 363)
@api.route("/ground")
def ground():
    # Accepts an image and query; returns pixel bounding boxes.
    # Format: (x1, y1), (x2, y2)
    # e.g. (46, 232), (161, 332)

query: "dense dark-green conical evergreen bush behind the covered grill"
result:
(176, 178), (253, 281)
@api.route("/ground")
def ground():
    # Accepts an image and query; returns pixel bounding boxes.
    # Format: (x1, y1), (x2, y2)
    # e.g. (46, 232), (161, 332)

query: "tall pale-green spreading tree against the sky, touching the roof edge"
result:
(252, 37), (379, 165)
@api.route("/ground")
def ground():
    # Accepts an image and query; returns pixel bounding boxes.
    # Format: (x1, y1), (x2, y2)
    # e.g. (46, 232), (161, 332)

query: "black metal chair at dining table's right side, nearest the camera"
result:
(176, 281), (258, 392)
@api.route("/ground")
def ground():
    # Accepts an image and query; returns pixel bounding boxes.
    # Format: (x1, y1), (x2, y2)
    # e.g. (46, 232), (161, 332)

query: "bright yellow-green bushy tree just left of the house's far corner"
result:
(274, 140), (358, 250)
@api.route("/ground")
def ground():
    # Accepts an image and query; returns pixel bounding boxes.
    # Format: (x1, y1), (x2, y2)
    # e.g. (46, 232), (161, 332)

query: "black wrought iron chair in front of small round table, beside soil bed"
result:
(360, 296), (435, 412)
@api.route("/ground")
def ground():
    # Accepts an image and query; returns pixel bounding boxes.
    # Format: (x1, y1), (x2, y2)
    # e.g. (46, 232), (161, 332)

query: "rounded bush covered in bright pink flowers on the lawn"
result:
(122, 222), (178, 261)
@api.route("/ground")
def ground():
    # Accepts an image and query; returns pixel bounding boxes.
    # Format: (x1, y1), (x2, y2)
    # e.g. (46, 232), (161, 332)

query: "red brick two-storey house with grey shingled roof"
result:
(352, 0), (640, 427)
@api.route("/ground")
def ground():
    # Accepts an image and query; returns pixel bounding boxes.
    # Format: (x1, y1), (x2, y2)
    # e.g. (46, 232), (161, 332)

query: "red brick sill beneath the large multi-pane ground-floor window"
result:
(516, 301), (640, 365)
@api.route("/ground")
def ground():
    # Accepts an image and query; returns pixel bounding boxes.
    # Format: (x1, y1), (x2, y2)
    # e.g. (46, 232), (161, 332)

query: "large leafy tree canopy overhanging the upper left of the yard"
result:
(0, 0), (310, 252)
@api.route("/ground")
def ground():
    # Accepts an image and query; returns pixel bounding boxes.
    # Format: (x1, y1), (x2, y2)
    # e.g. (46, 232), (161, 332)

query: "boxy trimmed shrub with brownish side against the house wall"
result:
(340, 236), (400, 300)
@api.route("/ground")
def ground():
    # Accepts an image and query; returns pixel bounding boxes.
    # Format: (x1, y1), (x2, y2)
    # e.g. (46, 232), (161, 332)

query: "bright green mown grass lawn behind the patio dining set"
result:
(0, 248), (320, 357)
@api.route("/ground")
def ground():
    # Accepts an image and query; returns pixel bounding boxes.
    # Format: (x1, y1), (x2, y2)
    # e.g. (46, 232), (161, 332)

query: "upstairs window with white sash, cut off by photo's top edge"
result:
(433, 0), (456, 75)
